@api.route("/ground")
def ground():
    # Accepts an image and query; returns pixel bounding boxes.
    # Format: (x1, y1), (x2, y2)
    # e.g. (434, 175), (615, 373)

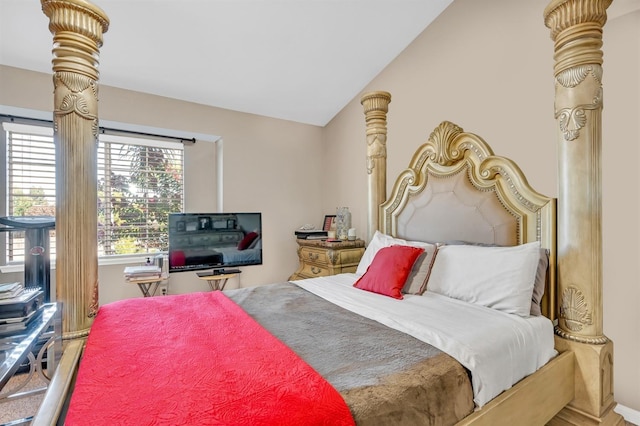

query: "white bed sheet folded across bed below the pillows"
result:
(293, 274), (557, 408)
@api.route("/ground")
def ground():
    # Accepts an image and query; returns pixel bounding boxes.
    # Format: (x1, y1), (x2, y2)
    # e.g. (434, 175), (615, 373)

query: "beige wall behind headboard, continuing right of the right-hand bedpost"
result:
(323, 0), (640, 410)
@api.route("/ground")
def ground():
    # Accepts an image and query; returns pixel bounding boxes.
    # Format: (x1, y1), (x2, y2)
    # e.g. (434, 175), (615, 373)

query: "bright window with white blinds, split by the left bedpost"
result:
(2, 122), (184, 263)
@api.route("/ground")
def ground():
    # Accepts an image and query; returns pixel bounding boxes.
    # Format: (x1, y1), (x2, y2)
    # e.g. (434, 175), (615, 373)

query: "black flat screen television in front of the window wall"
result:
(169, 213), (262, 273)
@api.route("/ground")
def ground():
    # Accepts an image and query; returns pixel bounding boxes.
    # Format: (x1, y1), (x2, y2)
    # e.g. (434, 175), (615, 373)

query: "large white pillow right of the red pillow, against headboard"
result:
(427, 241), (540, 317)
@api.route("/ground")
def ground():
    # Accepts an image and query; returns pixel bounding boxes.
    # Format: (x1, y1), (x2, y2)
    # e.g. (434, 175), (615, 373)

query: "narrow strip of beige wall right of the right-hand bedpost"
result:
(602, 5), (640, 411)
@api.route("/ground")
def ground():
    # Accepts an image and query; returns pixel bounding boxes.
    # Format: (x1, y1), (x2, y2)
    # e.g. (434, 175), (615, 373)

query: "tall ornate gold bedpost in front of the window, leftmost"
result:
(41, 0), (109, 339)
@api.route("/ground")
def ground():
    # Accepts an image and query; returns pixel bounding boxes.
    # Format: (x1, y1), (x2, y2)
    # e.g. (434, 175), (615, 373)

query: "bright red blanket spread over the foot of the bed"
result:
(65, 291), (354, 426)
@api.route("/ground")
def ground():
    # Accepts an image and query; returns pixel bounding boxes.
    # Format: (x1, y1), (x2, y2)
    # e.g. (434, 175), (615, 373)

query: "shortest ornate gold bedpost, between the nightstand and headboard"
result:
(360, 92), (391, 241)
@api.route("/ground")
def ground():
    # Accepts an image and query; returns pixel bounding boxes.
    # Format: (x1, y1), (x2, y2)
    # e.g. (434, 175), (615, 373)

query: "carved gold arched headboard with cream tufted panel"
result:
(379, 121), (556, 319)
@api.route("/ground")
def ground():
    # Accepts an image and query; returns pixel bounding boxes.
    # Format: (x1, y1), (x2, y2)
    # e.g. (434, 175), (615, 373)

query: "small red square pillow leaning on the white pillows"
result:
(353, 245), (424, 299)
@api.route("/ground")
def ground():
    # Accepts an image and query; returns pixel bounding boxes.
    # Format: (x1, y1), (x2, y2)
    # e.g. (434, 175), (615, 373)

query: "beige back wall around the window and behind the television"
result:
(0, 66), (324, 303)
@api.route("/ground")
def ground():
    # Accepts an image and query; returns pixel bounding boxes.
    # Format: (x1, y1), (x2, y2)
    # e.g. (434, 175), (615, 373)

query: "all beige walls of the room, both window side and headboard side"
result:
(0, 0), (640, 416)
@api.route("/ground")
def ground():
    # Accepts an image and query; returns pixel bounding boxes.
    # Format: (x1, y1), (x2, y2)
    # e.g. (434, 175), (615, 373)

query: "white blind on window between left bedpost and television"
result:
(98, 135), (184, 255)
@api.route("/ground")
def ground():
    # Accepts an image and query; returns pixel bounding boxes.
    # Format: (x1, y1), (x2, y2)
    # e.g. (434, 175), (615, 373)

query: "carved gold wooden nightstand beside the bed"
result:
(289, 239), (364, 280)
